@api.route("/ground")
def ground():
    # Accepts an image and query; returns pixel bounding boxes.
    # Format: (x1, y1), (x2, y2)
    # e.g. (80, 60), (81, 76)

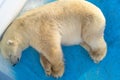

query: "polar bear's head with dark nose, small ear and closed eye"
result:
(0, 34), (26, 65)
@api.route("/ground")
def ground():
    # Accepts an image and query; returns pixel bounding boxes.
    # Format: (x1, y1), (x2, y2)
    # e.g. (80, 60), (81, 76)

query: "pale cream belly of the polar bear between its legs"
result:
(61, 21), (82, 45)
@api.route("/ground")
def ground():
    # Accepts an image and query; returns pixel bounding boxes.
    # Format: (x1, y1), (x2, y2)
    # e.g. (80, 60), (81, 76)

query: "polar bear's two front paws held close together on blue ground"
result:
(40, 55), (64, 78)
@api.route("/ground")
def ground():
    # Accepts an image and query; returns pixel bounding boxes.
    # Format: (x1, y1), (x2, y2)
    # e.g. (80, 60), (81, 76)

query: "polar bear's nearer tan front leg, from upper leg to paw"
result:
(40, 33), (64, 78)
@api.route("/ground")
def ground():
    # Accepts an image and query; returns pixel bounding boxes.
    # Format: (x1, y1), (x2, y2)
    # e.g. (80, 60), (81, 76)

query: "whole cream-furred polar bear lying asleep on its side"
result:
(0, 0), (107, 77)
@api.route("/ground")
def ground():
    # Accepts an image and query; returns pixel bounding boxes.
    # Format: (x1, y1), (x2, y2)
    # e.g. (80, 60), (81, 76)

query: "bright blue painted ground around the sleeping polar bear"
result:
(14, 0), (120, 80)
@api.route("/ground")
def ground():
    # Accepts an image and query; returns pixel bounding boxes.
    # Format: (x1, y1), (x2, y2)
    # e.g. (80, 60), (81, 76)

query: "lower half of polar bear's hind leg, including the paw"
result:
(82, 35), (107, 63)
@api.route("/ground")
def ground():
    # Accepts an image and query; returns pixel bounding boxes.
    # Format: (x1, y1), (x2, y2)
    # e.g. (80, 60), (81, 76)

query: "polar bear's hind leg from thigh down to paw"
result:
(82, 21), (107, 63)
